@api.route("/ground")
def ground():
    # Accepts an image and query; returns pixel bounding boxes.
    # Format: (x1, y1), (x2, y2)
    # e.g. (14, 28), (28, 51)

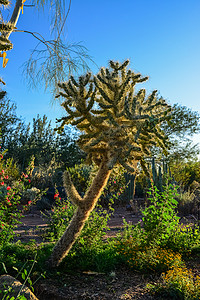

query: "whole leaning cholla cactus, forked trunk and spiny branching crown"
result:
(49, 60), (173, 267)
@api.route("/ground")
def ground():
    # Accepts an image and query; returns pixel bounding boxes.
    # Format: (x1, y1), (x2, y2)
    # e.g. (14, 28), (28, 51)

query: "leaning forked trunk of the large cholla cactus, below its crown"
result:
(48, 157), (111, 267)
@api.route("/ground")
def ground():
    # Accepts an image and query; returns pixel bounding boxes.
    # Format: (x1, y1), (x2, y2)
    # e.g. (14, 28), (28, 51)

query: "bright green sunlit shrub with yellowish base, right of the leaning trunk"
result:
(115, 185), (200, 272)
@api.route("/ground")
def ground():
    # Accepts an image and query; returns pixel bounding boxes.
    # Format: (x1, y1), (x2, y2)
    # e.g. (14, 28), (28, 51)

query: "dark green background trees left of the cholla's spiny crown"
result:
(0, 95), (85, 172)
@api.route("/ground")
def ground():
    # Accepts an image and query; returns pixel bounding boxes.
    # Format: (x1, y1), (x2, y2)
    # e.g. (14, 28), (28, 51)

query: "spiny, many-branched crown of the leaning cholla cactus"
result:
(58, 60), (171, 173)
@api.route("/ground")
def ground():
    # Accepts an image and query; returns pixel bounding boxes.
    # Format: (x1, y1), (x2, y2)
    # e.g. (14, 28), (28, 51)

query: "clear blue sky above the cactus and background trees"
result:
(1, 0), (200, 145)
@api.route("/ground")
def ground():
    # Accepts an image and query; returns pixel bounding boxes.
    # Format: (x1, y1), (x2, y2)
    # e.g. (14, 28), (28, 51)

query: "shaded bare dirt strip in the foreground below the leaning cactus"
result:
(35, 269), (155, 300)
